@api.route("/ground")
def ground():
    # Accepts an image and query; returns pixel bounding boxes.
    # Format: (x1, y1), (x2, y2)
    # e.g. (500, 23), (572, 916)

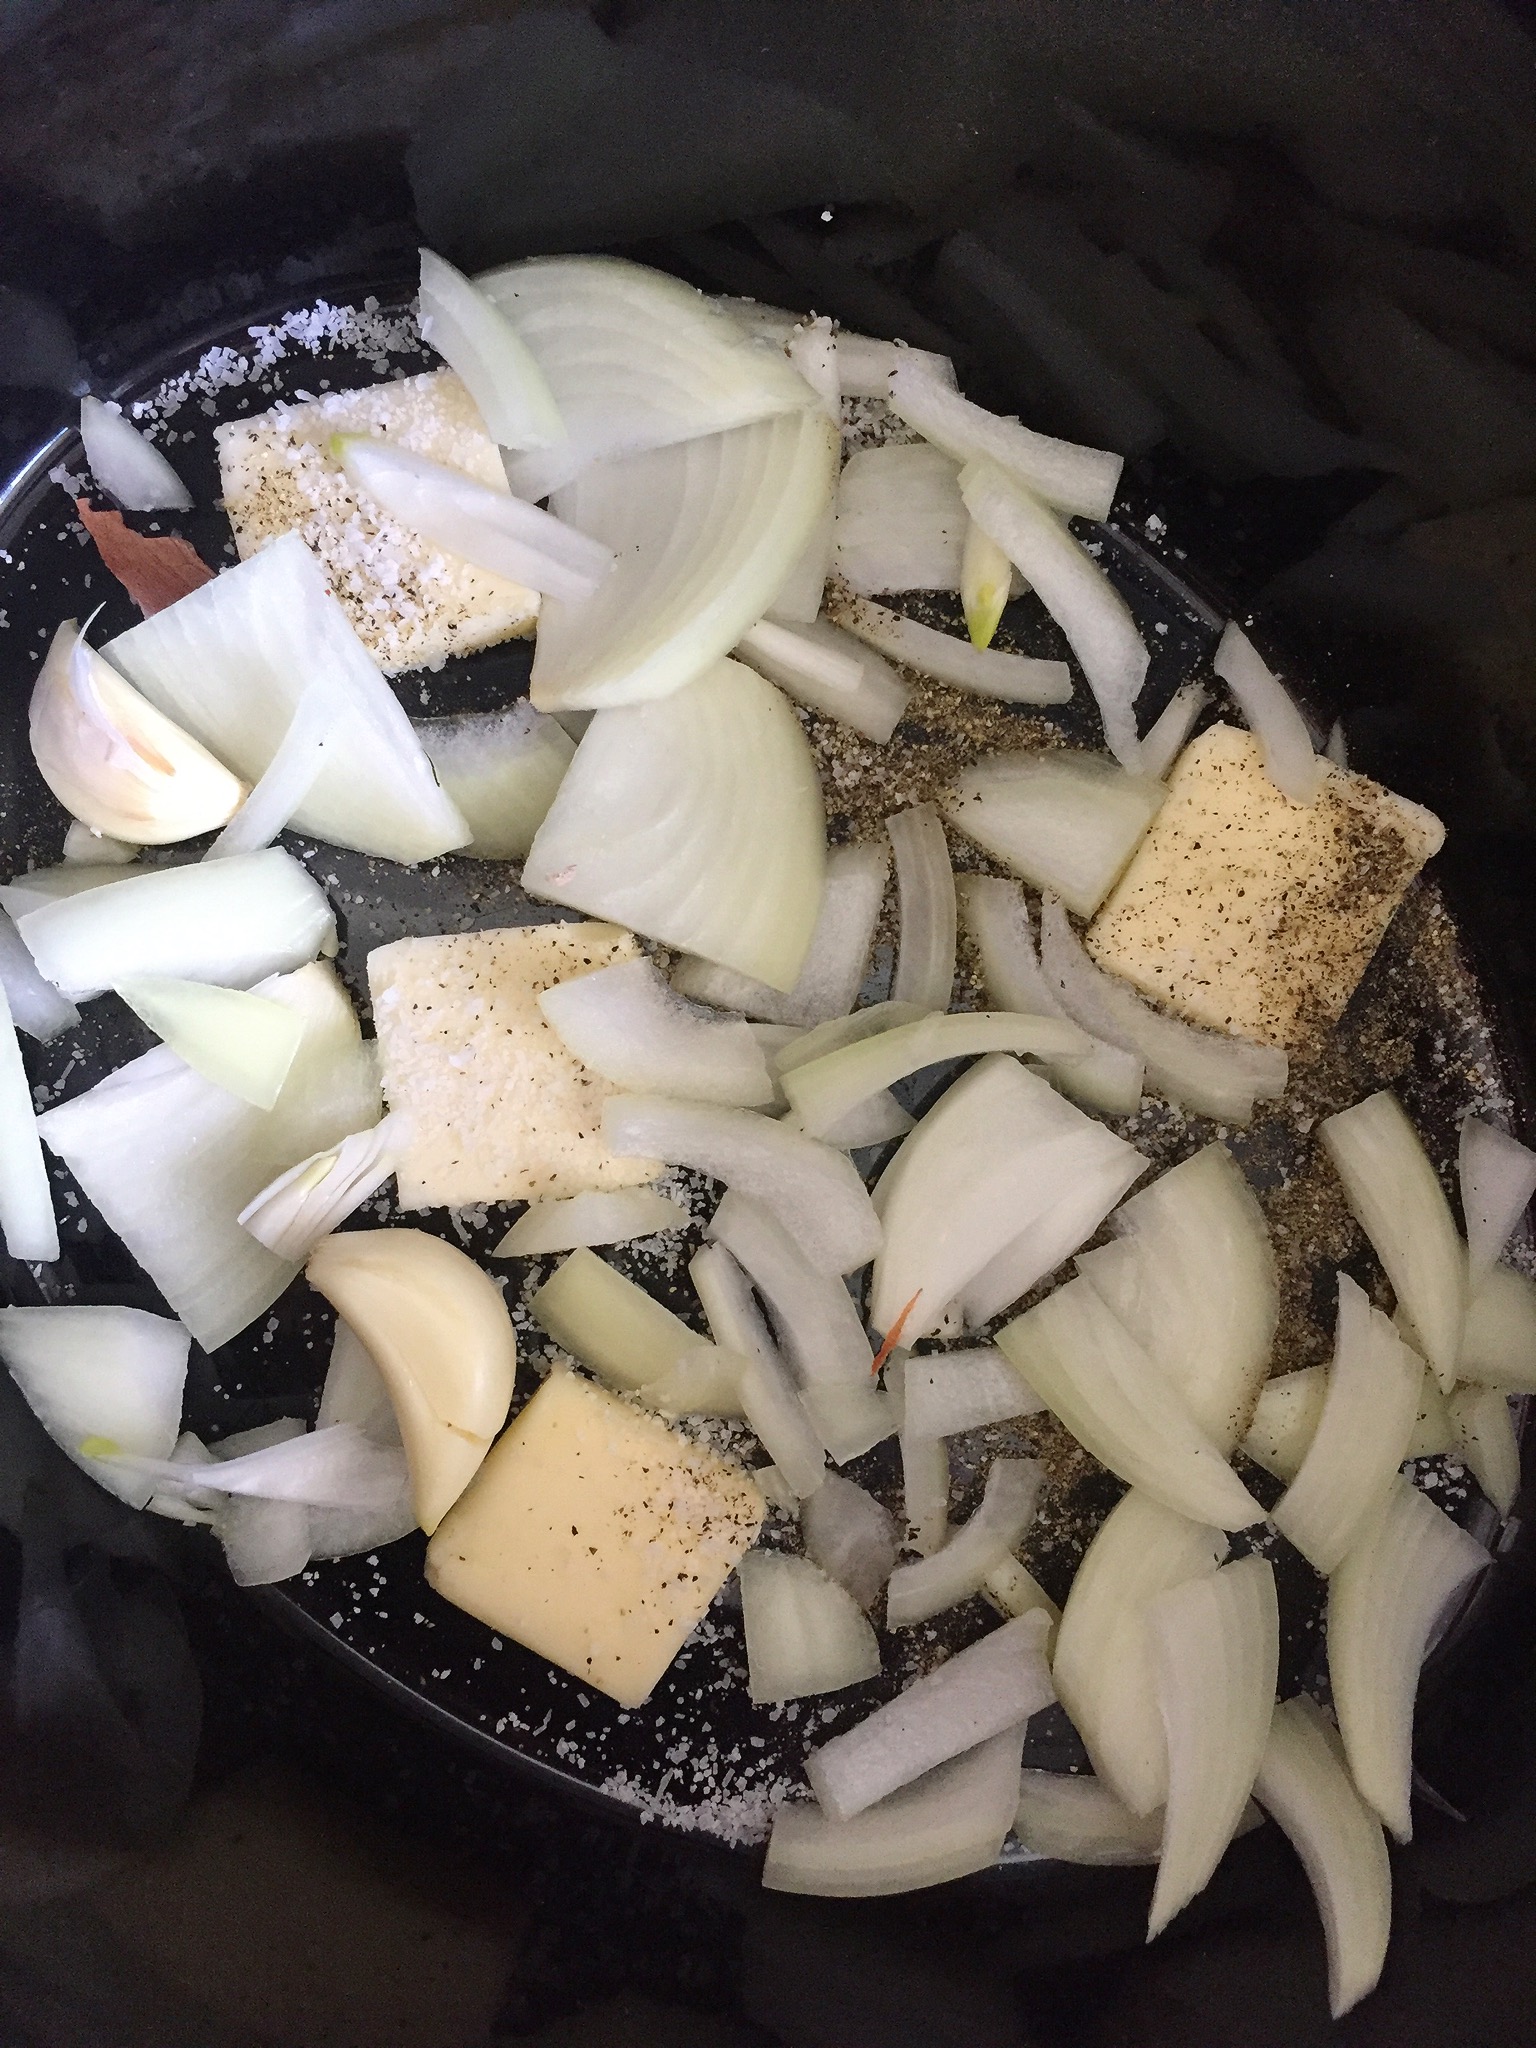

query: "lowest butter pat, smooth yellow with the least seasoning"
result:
(426, 1372), (764, 1706)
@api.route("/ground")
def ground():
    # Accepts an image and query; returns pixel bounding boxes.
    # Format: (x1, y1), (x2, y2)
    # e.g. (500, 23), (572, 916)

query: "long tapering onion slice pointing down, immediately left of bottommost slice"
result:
(1147, 1556), (1280, 1942)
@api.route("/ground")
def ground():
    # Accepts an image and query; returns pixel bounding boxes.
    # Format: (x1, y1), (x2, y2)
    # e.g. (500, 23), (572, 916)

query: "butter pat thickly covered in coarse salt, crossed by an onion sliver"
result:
(215, 371), (539, 676)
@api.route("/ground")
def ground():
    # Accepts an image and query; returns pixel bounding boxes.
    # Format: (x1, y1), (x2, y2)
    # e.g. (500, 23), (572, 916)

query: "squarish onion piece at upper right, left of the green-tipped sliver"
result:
(831, 444), (967, 598)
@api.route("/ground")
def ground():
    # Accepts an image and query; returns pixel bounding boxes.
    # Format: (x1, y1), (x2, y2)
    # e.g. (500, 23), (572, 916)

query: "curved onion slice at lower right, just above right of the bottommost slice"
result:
(1327, 1479), (1489, 1841)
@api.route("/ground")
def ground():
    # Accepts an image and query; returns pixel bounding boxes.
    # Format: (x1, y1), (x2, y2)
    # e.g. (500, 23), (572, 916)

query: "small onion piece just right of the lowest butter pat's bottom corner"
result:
(737, 1550), (881, 1706)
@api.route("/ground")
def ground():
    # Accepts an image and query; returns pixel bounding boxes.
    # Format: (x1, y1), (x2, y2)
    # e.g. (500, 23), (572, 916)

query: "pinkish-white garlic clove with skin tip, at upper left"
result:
(29, 618), (246, 846)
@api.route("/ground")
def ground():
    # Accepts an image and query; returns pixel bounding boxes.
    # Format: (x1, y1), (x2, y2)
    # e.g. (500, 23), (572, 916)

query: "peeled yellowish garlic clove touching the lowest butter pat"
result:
(305, 1229), (518, 1536)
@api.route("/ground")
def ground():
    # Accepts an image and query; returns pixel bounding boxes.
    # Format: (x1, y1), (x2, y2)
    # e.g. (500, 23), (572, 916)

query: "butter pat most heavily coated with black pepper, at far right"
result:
(1087, 725), (1446, 1047)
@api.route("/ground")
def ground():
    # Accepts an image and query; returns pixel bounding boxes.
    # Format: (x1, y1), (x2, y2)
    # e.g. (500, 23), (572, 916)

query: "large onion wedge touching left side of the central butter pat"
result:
(37, 962), (379, 1352)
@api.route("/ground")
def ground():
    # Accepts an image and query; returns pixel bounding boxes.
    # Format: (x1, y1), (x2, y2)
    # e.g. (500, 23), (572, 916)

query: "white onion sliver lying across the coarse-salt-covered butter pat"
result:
(338, 434), (614, 604)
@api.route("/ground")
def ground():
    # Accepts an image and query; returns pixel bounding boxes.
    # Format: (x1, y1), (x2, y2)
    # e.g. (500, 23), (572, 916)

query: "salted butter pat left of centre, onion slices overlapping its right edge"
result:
(369, 924), (662, 1208)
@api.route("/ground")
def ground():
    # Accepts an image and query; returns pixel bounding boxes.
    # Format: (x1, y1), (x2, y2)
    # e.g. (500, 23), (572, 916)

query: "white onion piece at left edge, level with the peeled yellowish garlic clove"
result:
(0, 1303), (193, 1507)
